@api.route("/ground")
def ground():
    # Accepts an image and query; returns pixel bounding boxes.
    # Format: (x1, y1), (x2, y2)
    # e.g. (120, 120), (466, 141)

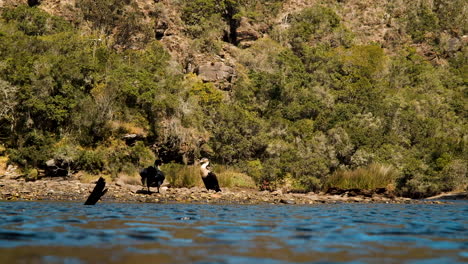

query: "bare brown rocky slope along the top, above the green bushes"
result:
(0, 0), (468, 89)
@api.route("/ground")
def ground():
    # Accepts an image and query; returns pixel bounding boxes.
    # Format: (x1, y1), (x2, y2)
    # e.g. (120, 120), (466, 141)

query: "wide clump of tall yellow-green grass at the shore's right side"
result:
(324, 164), (398, 189)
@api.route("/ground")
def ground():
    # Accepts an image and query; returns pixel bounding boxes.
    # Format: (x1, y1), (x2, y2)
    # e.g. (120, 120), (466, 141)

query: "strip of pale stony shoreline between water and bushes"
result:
(0, 178), (446, 205)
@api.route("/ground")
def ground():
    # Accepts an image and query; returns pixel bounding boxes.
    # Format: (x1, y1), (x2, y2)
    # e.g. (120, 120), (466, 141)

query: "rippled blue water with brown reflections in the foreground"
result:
(0, 202), (468, 264)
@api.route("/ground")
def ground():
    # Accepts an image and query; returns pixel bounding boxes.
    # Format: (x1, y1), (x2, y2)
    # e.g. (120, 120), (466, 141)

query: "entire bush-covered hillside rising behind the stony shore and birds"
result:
(0, 0), (468, 197)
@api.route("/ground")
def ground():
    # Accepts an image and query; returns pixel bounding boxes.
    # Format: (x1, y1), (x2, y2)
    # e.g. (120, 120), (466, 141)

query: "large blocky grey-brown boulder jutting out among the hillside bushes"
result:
(195, 62), (235, 83)
